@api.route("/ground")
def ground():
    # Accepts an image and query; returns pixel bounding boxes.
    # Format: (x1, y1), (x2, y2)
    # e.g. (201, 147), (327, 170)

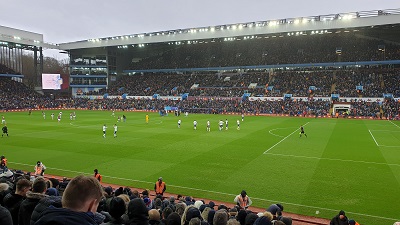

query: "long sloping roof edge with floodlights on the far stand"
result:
(59, 9), (400, 50)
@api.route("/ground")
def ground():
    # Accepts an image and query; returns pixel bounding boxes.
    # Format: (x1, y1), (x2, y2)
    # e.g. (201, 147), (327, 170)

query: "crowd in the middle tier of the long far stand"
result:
(85, 68), (400, 97)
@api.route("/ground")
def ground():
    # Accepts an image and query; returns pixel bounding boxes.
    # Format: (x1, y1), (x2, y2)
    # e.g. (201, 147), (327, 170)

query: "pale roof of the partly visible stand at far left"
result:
(0, 26), (58, 50)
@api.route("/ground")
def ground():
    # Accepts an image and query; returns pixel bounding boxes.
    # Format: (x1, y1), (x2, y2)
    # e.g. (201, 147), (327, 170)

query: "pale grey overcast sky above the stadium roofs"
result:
(0, 0), (400, 58)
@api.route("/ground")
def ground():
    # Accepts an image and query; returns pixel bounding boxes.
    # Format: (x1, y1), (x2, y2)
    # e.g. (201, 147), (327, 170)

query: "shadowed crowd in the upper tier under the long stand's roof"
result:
(131, 33), (400, 69)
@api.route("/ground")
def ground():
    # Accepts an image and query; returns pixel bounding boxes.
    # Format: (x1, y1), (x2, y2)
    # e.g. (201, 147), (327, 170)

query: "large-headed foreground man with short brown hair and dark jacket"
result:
(34, 175), (103, 225)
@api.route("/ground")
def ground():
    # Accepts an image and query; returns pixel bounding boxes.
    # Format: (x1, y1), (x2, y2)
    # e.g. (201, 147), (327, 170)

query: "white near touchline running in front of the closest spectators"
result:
(8, 162), (398, 220)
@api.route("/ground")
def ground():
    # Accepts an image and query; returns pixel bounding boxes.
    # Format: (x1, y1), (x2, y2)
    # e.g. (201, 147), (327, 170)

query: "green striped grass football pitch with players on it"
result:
(0, 110), (400, 225)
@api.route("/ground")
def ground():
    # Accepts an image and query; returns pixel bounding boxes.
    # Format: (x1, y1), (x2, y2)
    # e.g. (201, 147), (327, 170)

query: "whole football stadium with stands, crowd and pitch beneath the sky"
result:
(0, 6), (400, 225)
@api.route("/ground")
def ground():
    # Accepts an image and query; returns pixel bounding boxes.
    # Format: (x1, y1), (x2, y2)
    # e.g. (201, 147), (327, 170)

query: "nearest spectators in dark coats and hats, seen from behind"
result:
(0, 163), (292, 225)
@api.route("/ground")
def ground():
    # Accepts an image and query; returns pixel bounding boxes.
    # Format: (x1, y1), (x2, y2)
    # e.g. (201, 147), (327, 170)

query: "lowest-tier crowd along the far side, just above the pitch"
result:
(0, 72), (400, 118)
